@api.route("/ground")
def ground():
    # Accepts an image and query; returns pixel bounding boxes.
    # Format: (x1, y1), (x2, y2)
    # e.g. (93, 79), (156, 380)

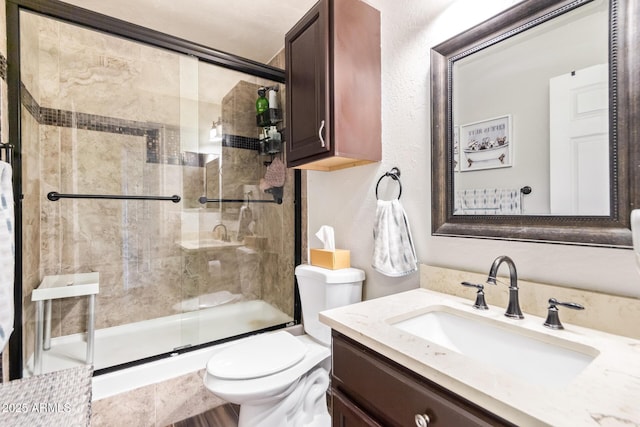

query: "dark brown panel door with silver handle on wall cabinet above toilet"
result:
(285, 0), (331, 166)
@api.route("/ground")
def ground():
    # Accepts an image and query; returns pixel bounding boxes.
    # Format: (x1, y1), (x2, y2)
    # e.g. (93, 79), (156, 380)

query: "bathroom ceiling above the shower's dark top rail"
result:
(58, 0), (317, 63)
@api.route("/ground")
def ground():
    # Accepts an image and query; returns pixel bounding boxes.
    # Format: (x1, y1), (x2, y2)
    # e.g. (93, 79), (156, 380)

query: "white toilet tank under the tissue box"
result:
(295, 264), (364, 346)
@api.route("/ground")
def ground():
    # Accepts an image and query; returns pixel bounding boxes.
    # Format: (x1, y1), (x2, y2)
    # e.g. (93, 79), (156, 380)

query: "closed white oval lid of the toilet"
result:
(207, 331), (307, 380)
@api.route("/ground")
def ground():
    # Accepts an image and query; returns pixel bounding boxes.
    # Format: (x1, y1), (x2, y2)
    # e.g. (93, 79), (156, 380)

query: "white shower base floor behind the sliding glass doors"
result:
(24, 300), (293, 377)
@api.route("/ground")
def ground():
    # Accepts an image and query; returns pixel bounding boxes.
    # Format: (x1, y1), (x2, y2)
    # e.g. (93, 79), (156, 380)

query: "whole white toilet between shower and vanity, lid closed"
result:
(204, 265), (364, 427)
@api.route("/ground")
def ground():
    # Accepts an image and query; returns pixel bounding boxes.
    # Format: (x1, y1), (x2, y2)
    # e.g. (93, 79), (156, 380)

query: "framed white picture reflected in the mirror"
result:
(459, 115), (513, 172)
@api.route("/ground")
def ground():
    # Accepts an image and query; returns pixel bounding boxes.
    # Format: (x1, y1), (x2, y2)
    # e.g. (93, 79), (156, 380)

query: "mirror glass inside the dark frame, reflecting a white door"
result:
(451, 0), (612, 216)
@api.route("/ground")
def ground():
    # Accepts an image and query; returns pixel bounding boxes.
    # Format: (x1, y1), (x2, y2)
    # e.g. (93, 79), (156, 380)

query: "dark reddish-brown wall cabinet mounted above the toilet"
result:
(285, 0), (382, 171)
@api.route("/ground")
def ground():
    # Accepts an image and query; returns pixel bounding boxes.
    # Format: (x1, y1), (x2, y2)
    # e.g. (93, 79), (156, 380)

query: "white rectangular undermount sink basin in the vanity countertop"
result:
(391, 306), (598, 387)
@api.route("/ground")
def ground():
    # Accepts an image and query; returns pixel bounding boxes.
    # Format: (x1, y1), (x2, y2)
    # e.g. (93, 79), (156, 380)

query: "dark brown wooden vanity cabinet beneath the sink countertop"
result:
(331, 331), (513, 427)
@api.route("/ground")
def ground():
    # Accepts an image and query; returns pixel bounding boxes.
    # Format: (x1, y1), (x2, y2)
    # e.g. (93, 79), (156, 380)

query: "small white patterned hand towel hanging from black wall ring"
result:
(371, 199), (418, 277)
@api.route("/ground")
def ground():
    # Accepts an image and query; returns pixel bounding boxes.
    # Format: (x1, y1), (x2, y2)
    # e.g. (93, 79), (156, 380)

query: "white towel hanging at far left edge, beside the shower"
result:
(0, 161), (15, 352)
